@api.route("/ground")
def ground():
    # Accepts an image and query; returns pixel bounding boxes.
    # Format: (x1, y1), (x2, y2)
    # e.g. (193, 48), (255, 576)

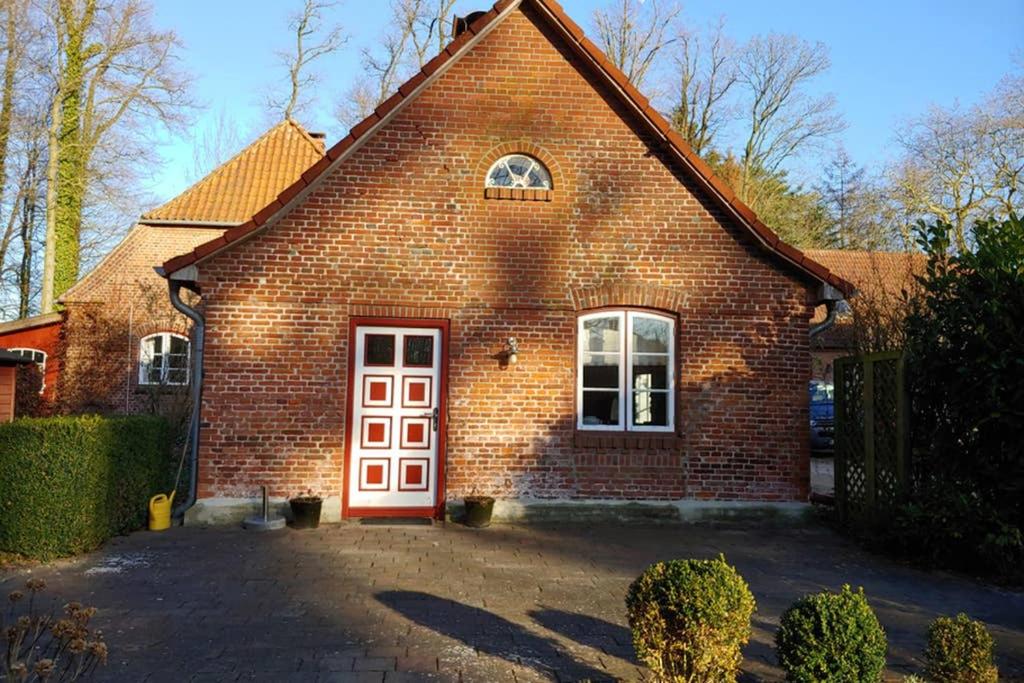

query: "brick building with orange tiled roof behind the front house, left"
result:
(0, 122), (325, 413)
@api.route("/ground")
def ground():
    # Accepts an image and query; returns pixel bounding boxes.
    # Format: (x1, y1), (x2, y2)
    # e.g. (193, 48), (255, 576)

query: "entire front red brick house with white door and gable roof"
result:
(155, 0), (852, 520)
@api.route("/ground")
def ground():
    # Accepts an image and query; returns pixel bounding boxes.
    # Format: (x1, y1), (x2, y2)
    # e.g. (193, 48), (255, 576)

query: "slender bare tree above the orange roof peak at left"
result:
(269, 0), (348, 121)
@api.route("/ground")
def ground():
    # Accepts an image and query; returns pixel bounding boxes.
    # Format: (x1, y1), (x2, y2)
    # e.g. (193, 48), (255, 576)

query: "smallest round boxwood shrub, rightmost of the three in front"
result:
(925, 613), (998, 683)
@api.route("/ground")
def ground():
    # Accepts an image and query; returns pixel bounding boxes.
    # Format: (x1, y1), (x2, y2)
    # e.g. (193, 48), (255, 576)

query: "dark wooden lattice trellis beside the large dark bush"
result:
(835, 351), (909, 525)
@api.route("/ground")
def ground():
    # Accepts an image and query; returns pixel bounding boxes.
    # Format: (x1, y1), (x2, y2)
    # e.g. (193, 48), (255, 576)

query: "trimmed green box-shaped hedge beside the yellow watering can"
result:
(0, 416), (172, 559)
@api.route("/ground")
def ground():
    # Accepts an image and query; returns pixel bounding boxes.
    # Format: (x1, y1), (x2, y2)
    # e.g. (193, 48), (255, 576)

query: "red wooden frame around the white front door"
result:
(341, 317), (450, 519)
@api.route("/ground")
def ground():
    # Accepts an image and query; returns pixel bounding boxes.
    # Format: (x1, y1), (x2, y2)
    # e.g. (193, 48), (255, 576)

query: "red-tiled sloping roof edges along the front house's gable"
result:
(158, 0), (855, 298)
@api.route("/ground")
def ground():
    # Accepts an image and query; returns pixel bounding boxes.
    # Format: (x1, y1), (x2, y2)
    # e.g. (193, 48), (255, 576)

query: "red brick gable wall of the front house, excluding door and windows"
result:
(200, 5), (811, 501)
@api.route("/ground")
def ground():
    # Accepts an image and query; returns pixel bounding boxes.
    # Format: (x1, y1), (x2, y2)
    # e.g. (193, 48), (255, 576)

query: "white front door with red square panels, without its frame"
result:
(347, 327), (442, 516)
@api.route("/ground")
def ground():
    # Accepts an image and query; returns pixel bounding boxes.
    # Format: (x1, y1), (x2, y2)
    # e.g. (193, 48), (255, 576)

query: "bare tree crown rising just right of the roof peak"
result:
(594, 0), (680, 89)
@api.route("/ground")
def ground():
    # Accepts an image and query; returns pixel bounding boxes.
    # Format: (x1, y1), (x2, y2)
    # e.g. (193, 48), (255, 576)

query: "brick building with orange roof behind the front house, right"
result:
(805, 249), (928, 383)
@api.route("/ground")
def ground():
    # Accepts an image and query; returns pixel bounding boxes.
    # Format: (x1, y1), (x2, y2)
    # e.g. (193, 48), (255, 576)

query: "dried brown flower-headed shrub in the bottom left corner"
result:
(0, 579), (108, 681)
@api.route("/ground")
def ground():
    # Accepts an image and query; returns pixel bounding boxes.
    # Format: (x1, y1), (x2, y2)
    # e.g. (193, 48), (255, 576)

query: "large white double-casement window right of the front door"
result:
(577, 309), (676, 432)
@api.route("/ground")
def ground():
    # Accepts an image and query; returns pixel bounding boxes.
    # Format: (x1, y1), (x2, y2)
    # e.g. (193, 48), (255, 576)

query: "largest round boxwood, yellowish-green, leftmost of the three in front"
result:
(626, 556), (755, 681)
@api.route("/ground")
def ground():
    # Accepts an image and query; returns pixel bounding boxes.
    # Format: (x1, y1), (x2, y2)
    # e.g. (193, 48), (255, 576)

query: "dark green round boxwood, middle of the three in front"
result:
(775, 586), (886, 683)
